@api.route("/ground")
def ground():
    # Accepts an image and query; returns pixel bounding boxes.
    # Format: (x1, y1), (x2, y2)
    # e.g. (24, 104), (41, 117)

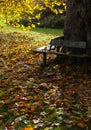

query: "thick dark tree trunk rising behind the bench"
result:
(64, 0), (91, 45)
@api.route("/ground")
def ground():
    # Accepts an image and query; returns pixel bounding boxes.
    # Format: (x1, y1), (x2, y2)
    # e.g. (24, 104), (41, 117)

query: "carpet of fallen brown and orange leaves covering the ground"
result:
(0, 32), (91, 130)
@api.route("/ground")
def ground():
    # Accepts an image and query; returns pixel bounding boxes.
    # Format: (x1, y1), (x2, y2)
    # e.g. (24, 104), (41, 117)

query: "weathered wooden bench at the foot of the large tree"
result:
(33, 38), (91, 66)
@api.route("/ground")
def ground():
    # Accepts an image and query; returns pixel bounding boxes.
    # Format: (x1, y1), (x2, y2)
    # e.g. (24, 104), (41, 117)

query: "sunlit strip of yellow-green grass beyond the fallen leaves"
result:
(0, 21), (63, 41)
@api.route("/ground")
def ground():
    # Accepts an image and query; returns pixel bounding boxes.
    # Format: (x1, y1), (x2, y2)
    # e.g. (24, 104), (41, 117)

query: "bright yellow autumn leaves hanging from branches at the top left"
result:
(0, 0), (66, 29)
